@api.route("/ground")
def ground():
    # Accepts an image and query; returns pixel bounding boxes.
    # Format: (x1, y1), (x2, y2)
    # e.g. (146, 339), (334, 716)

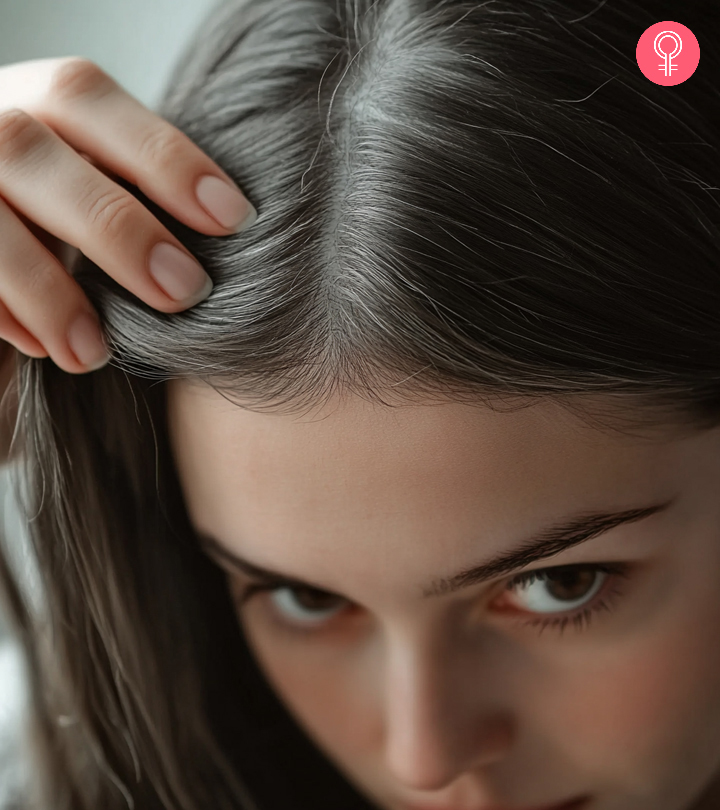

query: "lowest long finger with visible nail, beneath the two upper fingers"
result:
(0, 199), (107, 373)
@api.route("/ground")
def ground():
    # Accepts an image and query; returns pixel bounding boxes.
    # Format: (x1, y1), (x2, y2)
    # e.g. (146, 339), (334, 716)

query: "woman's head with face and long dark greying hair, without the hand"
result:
(3, 0), (720, 810)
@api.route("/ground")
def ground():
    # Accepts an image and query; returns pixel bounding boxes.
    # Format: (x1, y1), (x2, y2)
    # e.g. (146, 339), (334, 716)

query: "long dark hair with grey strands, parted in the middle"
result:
(0, 0), (720, 810)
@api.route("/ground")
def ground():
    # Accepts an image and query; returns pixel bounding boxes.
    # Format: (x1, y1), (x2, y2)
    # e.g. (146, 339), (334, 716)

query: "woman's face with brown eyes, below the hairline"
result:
(168, 381), (720, 810)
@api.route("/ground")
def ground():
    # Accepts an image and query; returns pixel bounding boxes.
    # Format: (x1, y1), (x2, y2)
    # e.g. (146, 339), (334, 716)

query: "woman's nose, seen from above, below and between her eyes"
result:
(384, 628), (513, 792)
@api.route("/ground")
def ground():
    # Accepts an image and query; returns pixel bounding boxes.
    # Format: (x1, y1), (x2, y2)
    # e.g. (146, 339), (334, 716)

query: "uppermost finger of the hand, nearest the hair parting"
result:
(8, 57), (257, 236)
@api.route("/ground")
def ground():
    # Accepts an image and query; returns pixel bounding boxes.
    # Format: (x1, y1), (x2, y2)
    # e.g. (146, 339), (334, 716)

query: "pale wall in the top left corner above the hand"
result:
(0, 0), (215, 107)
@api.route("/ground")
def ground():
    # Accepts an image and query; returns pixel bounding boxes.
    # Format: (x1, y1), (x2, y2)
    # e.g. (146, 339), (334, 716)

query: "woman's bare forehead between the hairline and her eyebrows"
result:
(163, 381), (693, 540)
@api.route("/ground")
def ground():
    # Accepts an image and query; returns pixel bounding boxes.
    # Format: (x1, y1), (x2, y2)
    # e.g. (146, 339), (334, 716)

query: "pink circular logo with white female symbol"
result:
(635, 20), (700, 87)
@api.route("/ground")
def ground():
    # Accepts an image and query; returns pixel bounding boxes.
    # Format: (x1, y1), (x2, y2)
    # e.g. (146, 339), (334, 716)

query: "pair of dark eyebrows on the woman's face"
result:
(197, 498), (675, 598)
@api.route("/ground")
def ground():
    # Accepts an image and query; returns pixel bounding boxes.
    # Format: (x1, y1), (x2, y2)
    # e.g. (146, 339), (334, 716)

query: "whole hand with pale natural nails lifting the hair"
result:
(0, 57), (256, 376)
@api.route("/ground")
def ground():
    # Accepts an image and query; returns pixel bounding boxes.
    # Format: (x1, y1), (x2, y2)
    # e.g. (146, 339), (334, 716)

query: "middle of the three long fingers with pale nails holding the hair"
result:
(0, 110), (212, 312)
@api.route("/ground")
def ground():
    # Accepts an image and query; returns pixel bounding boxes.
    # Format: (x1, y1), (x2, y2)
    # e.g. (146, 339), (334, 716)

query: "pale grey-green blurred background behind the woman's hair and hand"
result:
(0, 0), (216, 796)
